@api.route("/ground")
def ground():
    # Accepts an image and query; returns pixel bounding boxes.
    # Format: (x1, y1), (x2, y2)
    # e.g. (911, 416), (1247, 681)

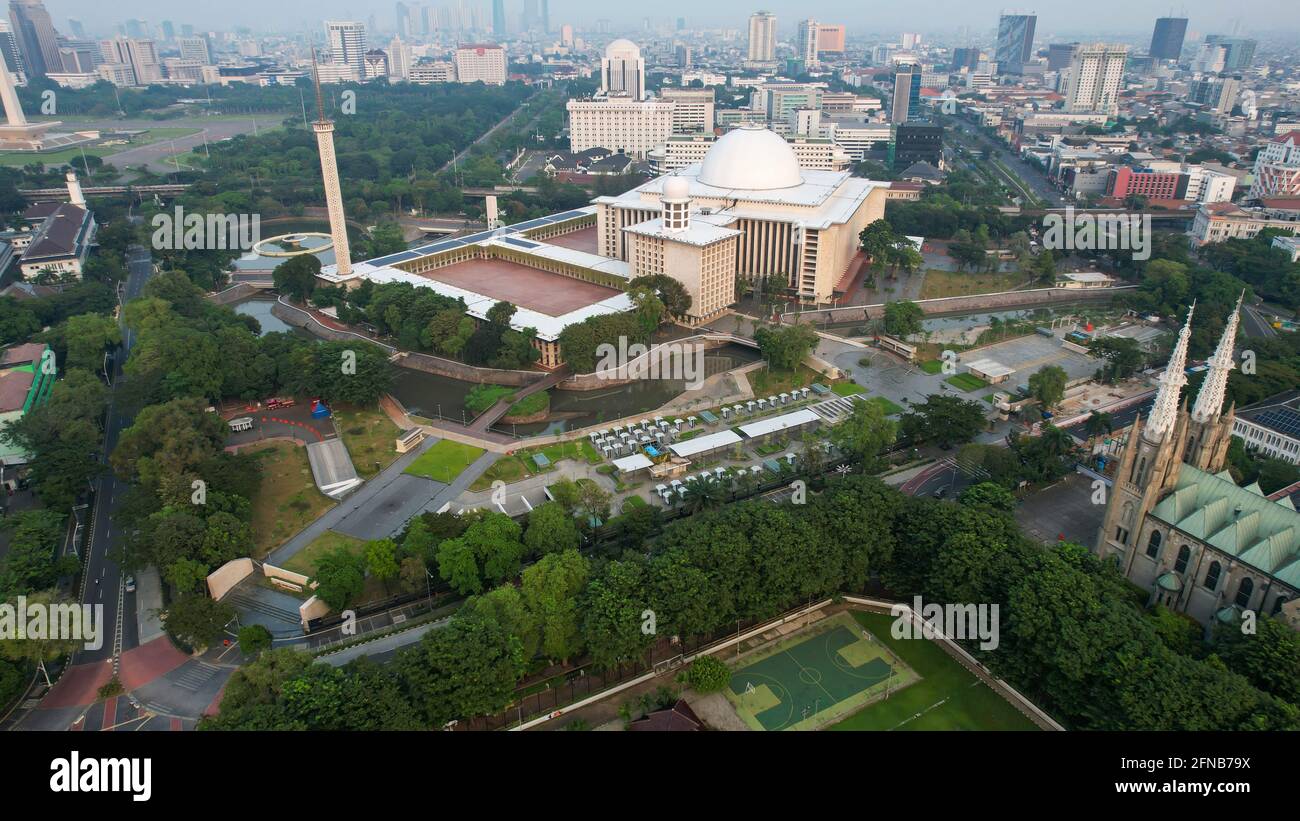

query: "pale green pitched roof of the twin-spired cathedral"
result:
(1152, 465), (1300, 588)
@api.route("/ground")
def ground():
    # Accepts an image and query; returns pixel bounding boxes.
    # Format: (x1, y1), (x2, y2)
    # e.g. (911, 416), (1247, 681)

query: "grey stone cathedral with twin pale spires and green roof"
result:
(1097, 300), (1300, 625)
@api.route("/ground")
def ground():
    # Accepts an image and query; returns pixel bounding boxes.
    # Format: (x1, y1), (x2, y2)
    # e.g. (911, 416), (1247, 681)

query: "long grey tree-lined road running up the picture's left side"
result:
(73, 247), (153, 664)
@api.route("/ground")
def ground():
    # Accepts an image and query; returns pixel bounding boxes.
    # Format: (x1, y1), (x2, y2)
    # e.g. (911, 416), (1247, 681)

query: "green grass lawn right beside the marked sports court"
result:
(829, 612), (1037, 730)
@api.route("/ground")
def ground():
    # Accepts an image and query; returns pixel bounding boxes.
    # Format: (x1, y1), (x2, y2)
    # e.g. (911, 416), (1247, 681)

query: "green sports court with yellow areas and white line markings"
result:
(725, 613), (917, 730)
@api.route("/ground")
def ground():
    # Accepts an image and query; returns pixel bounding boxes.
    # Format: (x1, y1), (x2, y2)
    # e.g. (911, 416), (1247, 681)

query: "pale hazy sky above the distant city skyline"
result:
(46, 0), (1300, 36)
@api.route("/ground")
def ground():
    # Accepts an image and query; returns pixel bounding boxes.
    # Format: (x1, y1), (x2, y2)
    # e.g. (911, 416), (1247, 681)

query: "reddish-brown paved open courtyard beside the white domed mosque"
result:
(421, 260), (619, 317)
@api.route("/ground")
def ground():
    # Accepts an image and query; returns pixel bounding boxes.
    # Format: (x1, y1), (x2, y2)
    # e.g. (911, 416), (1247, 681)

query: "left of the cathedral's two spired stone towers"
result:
(1097, 304), (1196, 575)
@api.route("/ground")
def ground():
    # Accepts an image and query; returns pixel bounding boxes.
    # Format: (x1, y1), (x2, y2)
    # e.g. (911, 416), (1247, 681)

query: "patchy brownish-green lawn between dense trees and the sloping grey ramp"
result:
(242, 442), (334, 559)
